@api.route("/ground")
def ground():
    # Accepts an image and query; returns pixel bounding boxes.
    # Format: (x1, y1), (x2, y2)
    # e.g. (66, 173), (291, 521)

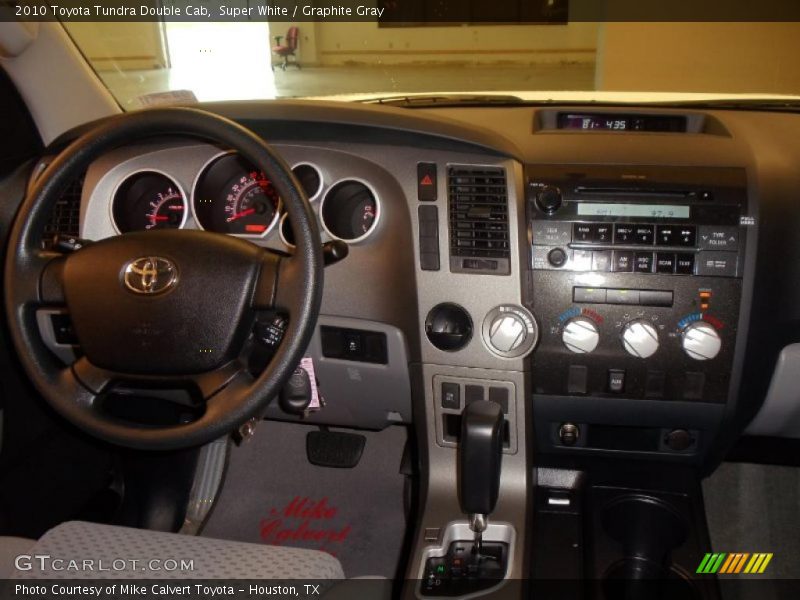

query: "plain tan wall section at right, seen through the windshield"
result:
(595, 23), (800, 94)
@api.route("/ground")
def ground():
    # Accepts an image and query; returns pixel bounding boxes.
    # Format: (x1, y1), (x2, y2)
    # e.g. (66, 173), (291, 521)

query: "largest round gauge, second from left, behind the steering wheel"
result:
(192, 154), (281, 237)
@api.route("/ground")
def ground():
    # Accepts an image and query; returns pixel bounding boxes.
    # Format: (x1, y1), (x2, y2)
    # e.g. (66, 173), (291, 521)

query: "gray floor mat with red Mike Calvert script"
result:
(202, 421), (407, 577)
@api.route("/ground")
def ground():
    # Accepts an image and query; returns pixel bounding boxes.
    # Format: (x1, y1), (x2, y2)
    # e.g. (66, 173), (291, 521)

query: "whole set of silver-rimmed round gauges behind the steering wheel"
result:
(111, 152), (380, 247)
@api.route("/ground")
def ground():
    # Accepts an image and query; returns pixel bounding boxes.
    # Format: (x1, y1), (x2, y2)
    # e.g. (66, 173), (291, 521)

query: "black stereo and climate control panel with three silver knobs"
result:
(527, 167), (754, 458)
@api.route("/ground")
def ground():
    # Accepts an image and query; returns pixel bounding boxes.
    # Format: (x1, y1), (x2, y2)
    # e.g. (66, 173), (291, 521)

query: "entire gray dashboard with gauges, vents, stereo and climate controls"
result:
(32, 101), (800, 468)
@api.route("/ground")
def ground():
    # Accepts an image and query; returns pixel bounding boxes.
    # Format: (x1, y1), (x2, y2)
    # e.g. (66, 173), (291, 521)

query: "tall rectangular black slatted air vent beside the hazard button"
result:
(447, 166), (511, 275)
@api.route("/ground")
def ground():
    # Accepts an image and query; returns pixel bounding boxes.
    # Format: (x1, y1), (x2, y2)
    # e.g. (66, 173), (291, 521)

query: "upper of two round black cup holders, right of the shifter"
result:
(602, 494), (689, 569)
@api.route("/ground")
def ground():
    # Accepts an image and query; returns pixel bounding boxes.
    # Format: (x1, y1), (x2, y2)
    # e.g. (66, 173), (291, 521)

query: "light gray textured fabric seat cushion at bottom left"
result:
(7, 521), (344, 579)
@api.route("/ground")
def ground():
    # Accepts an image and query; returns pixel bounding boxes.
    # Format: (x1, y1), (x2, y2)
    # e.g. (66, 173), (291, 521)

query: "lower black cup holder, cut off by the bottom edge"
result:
(602, 558), (700, 600)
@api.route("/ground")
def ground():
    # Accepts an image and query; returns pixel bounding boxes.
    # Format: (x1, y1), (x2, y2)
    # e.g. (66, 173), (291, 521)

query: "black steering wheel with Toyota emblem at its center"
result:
(5, 108), (323, 449)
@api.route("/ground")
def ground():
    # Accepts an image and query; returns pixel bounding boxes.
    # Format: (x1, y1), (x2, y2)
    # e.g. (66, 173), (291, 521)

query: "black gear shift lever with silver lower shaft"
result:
(458, 400), (503, 554)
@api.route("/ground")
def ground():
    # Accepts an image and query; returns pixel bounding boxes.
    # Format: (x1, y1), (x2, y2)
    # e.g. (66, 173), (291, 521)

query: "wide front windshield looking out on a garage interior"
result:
(64, 9), (800, 110)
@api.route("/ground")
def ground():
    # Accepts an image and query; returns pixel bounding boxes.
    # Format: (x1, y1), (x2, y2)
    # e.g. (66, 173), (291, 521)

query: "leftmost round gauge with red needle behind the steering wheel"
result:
(111, 171), (188, 233)
